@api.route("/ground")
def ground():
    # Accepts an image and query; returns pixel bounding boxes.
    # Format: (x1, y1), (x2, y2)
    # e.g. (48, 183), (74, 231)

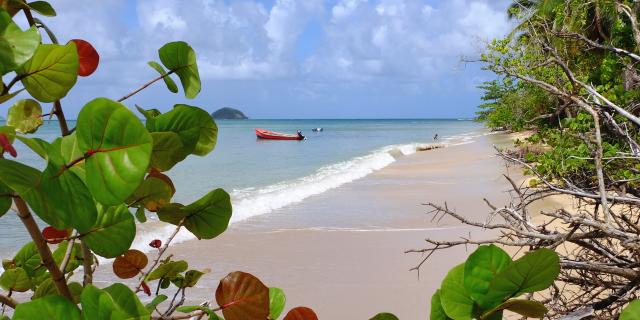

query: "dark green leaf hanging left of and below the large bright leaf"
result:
(38, 137), (98, 233)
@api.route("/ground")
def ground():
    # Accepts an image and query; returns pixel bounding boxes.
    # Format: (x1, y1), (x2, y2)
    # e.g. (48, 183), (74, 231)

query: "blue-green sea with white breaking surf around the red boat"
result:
(0, 120), (483, 258)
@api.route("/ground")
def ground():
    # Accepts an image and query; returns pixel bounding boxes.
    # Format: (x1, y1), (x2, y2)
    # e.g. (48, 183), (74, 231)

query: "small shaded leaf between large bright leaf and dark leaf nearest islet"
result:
(151, 132), (190, 171)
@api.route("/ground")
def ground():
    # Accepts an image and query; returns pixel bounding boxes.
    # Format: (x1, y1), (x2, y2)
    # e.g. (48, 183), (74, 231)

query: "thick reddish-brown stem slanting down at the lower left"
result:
(13, 197), (73, 301)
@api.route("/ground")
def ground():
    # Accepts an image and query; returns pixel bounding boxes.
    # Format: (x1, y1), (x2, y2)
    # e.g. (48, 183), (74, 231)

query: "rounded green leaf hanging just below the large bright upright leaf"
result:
(82, 205), (136, 258)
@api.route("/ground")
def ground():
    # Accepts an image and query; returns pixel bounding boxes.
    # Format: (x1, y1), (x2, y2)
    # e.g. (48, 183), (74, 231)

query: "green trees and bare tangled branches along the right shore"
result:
(410, 0), (640, 319)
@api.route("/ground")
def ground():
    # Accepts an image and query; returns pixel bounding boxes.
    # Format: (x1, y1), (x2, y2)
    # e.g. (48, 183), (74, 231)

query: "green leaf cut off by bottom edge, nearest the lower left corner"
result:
(13, 295), (80, 320)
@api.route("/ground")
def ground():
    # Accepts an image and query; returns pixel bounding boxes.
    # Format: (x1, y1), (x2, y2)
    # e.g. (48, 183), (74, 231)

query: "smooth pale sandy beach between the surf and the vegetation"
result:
(97, 135), (536, 319)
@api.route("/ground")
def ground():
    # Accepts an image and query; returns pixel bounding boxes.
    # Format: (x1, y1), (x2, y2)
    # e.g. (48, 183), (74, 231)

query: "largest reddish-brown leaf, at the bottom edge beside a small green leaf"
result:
(216, 271), (269, 320)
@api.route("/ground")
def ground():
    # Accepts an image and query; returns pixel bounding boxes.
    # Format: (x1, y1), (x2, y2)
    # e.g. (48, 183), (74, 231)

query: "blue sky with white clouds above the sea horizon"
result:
(15, 0), (511, 119)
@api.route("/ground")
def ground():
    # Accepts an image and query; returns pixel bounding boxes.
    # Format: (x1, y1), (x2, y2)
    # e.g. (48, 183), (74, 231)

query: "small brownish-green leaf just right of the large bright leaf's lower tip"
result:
(127, 176), (173, 212)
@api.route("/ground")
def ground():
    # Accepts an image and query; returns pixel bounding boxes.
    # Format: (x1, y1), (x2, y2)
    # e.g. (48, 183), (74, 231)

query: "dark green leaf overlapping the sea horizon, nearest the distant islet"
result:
(147, 104), (218, 156)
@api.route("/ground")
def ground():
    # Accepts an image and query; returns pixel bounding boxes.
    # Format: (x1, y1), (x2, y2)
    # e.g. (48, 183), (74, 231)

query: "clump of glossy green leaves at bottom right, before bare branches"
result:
(431, 245), (560, 320)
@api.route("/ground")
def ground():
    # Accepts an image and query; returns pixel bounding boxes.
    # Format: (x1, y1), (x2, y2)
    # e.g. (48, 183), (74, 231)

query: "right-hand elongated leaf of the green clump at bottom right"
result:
(478, 248), (560, 309)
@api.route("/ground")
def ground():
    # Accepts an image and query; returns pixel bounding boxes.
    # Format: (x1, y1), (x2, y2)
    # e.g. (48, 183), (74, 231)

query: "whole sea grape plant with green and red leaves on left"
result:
(0, 0), (317, 320)
